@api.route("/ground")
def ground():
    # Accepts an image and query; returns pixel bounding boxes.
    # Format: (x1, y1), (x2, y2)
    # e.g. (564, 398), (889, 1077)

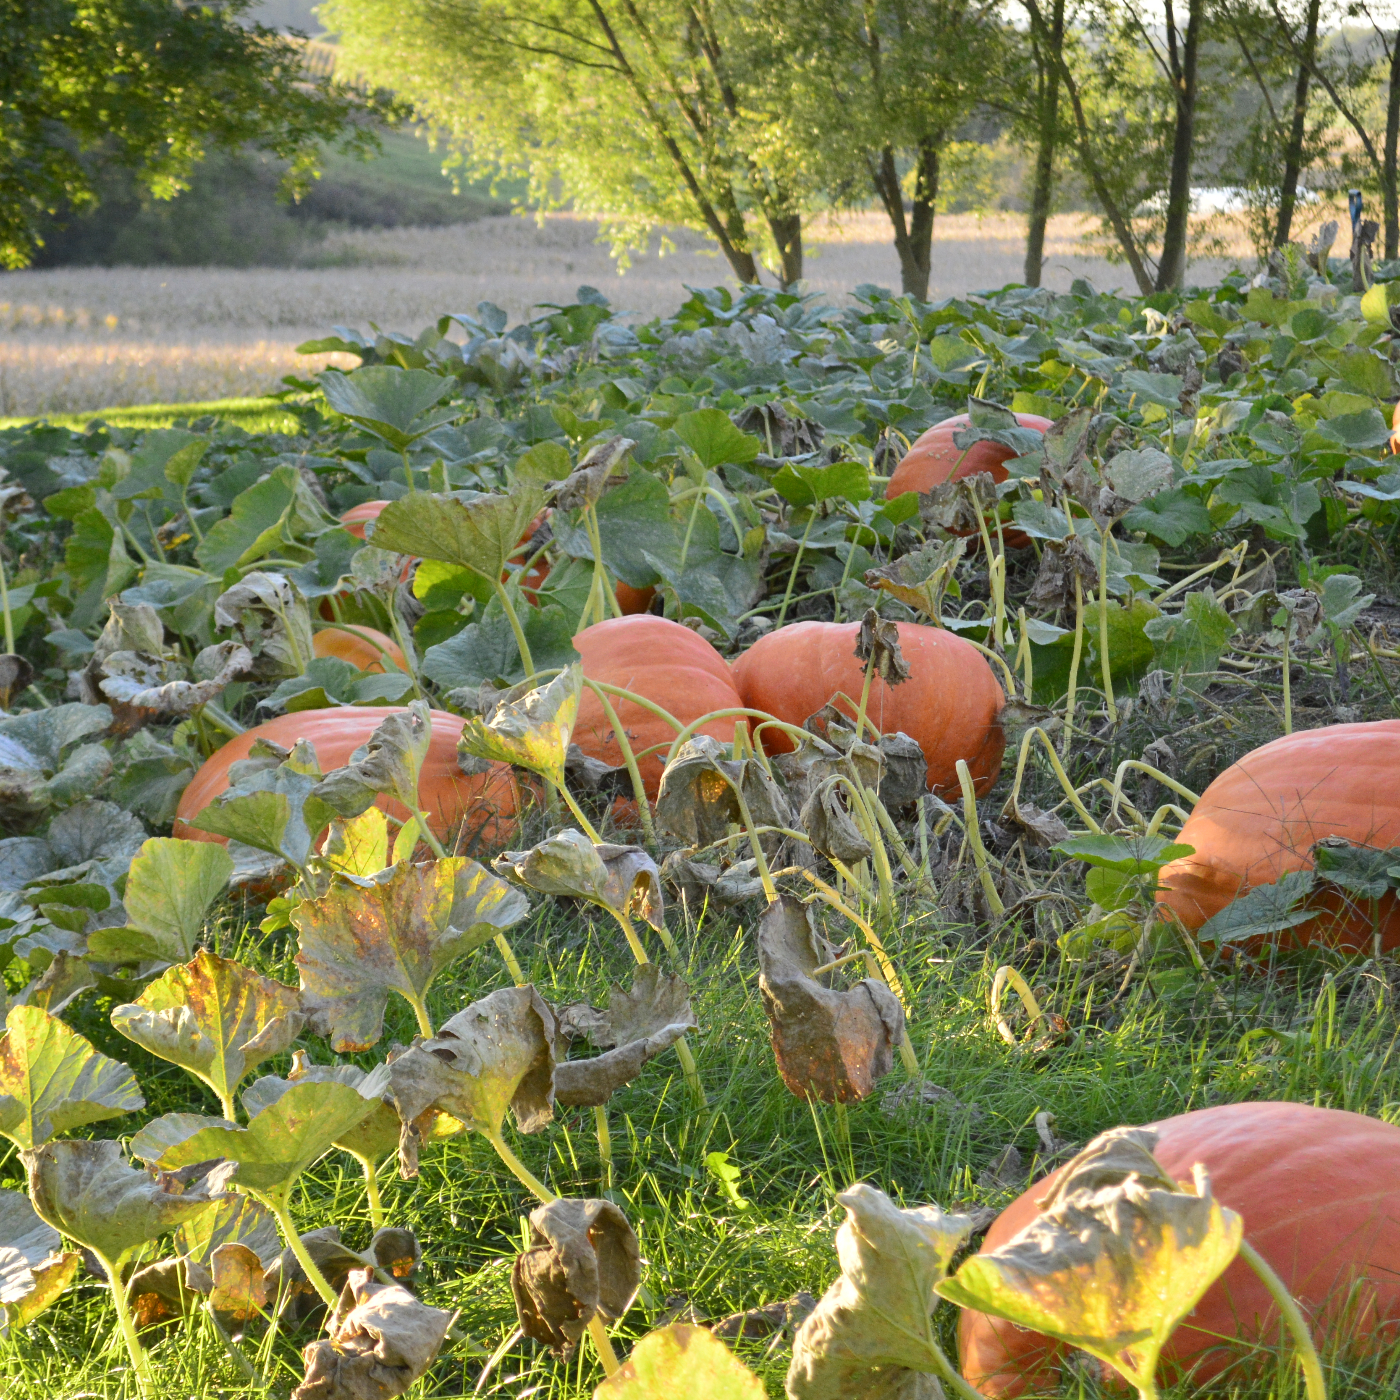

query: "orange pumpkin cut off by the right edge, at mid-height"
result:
(1158, 720), (1400, 951)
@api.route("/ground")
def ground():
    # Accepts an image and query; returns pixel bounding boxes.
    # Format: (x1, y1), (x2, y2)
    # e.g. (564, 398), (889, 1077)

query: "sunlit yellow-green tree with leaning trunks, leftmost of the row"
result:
(319, 0), (808, 284)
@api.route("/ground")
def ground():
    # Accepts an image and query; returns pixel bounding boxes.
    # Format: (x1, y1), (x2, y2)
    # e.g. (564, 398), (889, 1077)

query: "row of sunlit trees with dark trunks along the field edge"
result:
(319, 0), (1400, 297)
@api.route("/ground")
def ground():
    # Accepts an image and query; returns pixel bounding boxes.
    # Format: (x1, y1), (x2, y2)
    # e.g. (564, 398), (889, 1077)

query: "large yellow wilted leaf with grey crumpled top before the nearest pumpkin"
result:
(938, 1128), (1243, 1389)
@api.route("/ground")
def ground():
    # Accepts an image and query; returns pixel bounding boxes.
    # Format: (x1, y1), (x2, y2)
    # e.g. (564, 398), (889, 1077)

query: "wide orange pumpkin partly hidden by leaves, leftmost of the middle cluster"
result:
(175, 706), (519, 851)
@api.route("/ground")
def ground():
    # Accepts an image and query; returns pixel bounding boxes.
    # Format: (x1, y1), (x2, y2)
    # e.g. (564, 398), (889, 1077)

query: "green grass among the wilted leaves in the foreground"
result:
(0, 851), (1400, 1400)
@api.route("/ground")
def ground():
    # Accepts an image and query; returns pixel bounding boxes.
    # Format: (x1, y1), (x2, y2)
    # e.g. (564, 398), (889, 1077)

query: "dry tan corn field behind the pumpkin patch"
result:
(0, 214), (1253, 416)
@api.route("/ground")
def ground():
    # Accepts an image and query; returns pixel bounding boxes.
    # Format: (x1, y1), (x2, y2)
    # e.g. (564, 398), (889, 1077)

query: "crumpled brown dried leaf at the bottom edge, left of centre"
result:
(293, 1268), (454, 1400)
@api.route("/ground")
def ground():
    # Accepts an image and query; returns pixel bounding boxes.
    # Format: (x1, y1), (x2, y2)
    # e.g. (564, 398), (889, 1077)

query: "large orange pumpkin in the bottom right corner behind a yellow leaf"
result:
(958, 1103), (1400, 1397)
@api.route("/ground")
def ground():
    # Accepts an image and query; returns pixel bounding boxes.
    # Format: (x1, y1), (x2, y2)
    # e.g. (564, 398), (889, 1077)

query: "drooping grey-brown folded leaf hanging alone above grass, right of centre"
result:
(759, 895), (904, 1103)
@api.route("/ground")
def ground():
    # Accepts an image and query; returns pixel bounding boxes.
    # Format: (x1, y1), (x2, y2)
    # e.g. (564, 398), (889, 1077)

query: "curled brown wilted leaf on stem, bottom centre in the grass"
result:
(511, 1198), (641, 1359)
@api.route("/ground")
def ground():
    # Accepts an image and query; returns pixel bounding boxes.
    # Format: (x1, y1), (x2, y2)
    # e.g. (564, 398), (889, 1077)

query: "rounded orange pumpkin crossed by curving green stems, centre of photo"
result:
(574, 613), (743, 797)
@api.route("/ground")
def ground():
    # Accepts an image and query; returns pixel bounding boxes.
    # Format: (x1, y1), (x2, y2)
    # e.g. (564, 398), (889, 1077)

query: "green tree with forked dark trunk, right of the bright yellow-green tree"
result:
(756, 0), (1008, 298)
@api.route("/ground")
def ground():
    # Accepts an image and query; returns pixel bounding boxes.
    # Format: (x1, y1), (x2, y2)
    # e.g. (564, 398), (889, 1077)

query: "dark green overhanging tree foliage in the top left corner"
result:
(0, 0), (393, 267)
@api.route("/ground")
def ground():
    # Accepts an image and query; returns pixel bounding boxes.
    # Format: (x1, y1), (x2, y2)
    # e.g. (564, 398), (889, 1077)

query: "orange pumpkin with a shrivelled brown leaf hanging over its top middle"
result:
(732, 622), (1007, 795)
